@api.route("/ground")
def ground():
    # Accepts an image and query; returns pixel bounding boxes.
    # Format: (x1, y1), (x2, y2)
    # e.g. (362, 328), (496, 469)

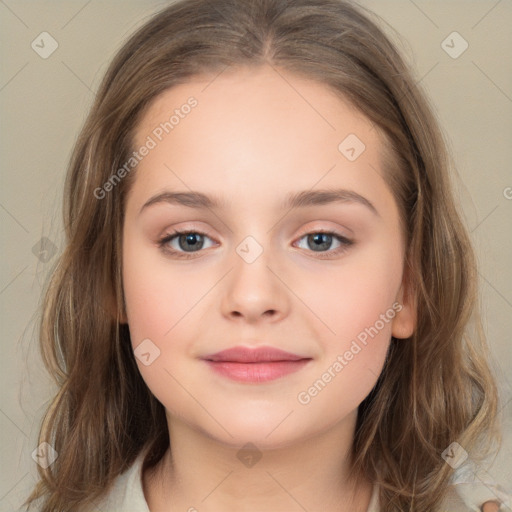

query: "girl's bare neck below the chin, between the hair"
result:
(143, 411), (372, 512)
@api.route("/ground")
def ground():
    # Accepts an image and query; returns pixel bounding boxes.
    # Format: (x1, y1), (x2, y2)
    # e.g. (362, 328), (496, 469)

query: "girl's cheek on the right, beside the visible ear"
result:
(297, 238), (403, 406)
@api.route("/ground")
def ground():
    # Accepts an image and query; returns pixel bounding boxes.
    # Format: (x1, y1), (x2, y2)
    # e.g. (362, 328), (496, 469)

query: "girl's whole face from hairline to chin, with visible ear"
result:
(123, 67), (413, 447)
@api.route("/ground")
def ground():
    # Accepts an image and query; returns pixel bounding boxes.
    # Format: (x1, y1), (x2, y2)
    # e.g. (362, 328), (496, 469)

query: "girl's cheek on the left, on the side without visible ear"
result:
(123, 237), (204, 410)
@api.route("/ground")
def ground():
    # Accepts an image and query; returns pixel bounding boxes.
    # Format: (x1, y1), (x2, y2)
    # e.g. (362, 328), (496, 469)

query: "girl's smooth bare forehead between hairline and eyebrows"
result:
(128, 66), (392, 216)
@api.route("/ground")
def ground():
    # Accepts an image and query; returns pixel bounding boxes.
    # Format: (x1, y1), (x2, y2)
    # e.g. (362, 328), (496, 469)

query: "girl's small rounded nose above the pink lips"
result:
(221, 244), (290, 323)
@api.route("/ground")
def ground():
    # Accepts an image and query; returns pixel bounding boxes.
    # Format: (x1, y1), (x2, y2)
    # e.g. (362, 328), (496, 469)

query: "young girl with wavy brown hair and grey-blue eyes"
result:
(22, 0), (498, 512)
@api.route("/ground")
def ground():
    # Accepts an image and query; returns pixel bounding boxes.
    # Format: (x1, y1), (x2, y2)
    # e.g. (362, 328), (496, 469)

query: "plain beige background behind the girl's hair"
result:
(0, 0), (512, 511)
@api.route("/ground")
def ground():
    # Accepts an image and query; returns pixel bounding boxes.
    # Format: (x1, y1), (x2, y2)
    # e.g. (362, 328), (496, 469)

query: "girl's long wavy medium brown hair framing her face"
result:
(25, 0), (497, 512)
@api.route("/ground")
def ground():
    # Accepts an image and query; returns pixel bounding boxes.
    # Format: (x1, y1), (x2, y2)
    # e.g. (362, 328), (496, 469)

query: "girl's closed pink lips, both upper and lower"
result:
(203, 346), (311, 382)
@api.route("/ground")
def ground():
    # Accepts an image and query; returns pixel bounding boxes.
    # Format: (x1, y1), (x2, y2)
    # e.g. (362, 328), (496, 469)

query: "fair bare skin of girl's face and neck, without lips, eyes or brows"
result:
(123, 66), (414, 512)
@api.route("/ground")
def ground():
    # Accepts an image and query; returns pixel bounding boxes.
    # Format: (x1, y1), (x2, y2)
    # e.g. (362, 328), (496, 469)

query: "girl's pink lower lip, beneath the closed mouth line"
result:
(206, 359), (311, 383)
